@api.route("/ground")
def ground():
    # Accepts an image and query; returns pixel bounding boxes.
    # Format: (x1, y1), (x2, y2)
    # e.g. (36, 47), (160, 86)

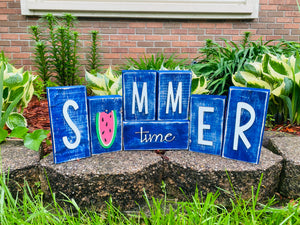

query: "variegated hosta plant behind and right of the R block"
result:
(232, 53), (300, 125)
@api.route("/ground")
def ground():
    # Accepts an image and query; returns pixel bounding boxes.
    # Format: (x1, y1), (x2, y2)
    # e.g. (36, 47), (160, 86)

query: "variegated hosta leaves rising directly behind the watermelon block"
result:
(85, 67), (122, 95)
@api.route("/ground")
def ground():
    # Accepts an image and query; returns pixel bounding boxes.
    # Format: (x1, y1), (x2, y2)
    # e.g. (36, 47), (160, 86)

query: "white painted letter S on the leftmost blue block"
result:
(63, 100), (81, 149)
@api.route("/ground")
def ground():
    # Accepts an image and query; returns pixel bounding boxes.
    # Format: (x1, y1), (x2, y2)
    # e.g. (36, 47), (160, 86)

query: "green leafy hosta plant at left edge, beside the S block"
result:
(0, 60), (49, 151)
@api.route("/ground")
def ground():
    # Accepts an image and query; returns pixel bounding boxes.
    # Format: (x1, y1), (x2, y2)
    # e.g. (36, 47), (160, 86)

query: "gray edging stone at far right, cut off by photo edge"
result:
(271, 136), (300, 198)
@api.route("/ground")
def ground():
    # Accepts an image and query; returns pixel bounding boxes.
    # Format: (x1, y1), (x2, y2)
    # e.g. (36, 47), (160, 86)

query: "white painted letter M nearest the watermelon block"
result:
(132, 82), (148, 114)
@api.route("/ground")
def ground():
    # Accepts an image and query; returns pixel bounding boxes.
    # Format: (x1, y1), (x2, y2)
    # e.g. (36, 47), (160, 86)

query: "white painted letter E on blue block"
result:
(198, 107), (215, 146)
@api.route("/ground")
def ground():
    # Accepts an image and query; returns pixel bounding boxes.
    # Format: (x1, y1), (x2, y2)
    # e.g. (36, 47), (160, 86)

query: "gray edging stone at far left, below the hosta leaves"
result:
(0, 140), (40, 195)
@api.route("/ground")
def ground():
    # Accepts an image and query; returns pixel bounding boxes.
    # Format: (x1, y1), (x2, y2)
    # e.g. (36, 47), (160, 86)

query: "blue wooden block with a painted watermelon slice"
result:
(88, 95), (122, 154)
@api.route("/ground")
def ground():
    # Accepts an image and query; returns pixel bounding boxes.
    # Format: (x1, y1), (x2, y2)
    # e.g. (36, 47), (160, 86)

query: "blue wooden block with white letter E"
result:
(190, 95), (226, 155)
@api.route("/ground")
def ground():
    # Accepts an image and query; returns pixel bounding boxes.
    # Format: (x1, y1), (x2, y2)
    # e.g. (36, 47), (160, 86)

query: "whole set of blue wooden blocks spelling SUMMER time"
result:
(47, 70), (270, 163)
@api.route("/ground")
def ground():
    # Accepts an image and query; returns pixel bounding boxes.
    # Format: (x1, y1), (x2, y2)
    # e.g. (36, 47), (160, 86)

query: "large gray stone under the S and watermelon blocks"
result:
(41, 151), (163, 210)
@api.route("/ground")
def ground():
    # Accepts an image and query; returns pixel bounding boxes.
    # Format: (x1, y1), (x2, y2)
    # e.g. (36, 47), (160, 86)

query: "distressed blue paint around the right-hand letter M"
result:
(157, 71), (192, 120)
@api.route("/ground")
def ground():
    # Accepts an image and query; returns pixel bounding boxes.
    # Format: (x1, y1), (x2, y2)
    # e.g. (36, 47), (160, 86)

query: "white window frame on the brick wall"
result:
(21, 0), (259, 19)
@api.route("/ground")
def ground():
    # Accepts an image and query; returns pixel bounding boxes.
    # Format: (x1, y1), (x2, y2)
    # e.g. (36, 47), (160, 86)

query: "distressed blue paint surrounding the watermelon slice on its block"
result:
(87, 95), (122, 154)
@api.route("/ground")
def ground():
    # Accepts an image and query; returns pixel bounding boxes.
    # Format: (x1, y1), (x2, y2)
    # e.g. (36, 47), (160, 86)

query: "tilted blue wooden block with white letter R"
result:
(222, 87), (270, 164)
